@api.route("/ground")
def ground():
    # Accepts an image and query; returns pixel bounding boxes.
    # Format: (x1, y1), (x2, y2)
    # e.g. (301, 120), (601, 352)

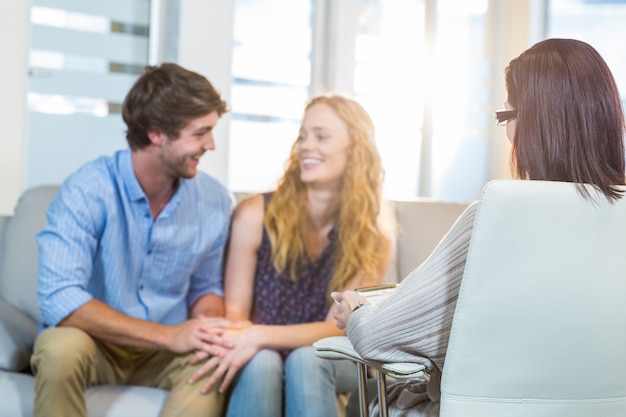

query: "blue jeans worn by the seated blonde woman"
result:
(226, 346), (357, 417)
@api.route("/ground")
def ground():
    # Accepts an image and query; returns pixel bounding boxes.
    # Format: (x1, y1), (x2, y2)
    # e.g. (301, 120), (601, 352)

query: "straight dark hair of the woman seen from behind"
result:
(505, 39), (625, 200)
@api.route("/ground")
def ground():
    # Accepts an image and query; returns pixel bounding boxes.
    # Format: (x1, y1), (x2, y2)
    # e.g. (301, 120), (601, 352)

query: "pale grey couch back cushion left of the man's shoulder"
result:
(0, 185), (59, 322)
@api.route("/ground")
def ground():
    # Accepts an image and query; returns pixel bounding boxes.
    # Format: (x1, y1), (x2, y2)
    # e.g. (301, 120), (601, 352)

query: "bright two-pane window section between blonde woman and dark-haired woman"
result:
(354, 0), (492, 201)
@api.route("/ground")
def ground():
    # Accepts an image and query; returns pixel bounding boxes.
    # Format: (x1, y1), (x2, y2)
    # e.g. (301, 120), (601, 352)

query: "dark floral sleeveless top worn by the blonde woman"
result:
(252, 193), (338, 354)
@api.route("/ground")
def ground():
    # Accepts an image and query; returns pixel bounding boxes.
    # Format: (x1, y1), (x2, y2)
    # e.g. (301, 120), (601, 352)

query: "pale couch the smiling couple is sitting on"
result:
(0, 186), (467, 417)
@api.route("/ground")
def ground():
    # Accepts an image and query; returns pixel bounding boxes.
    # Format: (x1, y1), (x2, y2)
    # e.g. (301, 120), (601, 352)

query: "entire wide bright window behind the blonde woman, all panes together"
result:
(228, 0), (492, 201)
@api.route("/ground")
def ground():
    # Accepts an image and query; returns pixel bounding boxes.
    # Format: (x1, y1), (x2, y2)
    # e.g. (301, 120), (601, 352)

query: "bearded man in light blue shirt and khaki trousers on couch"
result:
(31, 63), (232, 417)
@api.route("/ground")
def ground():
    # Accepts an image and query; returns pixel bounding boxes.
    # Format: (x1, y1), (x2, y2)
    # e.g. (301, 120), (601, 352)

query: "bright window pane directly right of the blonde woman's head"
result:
(352, 0), (429, 197)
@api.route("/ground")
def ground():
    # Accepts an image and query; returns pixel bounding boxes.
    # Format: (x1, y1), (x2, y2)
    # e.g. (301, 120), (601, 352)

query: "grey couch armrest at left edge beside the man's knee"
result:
(0, 300), (37, 372)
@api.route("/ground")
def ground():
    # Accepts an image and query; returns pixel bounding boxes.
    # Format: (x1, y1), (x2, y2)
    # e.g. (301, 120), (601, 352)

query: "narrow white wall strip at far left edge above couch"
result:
(0, 0), (30, 215)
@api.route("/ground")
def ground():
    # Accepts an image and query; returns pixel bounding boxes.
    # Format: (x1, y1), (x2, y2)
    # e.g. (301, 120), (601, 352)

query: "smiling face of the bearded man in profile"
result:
(159, 111), (219, 178)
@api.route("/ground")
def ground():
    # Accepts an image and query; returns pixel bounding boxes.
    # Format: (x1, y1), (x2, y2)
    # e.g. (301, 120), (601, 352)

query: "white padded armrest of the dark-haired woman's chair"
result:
(313, 336), (428, 379)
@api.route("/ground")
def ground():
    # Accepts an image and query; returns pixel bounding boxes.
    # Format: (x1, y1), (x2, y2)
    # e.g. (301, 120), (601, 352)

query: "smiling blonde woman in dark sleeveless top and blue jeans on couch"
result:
(188, 94), (392, 417)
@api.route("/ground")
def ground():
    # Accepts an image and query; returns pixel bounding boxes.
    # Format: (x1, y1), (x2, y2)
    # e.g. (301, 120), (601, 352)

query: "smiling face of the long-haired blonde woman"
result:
(296, 103), (350, 186)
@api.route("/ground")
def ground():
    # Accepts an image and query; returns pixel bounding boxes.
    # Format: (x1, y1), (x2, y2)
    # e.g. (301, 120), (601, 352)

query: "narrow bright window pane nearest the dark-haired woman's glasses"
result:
(422, 0), (488, 201)
